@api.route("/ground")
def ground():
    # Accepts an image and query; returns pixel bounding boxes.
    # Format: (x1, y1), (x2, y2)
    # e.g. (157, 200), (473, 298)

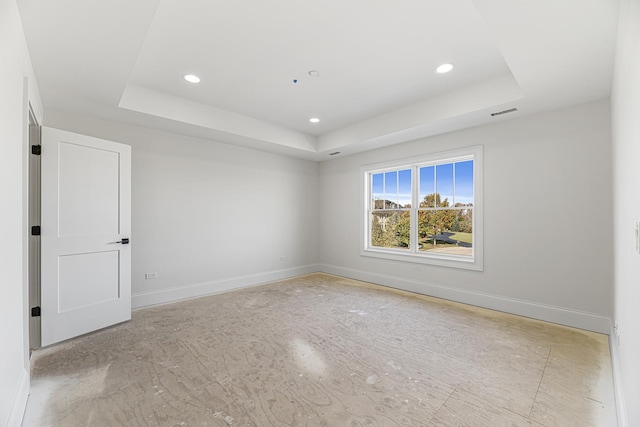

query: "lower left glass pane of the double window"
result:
(371, 211), (411, 249)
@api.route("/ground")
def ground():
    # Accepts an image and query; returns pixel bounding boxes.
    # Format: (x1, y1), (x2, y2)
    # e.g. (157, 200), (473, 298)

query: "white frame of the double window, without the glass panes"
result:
(360, 145), (484, 271)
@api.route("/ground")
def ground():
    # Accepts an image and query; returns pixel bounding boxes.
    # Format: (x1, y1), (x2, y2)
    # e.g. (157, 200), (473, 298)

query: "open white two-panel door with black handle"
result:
(41, 127), (131, 346)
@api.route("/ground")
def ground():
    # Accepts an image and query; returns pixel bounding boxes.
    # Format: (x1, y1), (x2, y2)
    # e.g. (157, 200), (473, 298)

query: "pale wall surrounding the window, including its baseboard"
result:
(319, 100), (613, 332)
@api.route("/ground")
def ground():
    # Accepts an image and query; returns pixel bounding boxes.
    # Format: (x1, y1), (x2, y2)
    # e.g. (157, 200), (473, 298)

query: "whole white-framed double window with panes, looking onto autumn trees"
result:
(362, 146), (483, 270)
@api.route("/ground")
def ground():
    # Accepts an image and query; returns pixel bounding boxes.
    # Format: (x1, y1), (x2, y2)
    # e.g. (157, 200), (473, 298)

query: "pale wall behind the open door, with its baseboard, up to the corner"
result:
(45, 111), (318, 307)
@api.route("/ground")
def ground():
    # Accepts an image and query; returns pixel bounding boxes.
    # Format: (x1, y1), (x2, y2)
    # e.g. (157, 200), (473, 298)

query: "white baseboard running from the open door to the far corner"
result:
(131, 264), (318, 308)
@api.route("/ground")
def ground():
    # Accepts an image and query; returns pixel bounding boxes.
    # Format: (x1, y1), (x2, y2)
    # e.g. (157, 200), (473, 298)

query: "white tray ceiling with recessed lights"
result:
(18, 0), (618, 160)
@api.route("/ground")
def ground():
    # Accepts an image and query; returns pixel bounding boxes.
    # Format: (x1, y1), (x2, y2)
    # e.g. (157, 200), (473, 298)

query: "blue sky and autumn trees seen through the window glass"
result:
(369, 160), (473, 256)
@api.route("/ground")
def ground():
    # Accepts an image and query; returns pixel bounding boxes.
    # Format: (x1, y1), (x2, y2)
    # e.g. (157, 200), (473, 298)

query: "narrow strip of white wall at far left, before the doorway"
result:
(0, 0), (39, 426)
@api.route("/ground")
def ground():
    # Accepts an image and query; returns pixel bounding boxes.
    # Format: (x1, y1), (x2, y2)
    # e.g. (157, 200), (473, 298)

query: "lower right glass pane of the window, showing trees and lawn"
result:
(418, 209), (473, 256)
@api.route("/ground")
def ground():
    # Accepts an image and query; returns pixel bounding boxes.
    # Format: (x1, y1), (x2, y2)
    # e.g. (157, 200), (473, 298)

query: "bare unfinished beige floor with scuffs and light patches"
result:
(24, 274), (616, 427)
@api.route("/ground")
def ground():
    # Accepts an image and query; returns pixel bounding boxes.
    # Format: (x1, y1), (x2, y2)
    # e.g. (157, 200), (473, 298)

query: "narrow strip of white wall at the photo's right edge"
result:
(611, 0), (640, 426)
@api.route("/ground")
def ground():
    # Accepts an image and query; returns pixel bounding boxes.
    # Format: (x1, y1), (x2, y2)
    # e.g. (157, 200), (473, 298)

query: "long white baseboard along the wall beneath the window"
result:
(319, 264), (611, 335)
